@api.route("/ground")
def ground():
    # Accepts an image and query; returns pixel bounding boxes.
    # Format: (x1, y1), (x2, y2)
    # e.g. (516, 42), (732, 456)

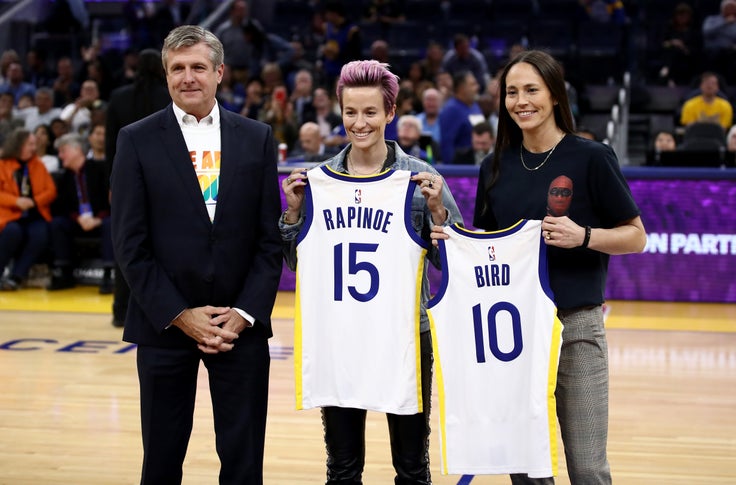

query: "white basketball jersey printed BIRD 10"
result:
(428, 220), (562, 478)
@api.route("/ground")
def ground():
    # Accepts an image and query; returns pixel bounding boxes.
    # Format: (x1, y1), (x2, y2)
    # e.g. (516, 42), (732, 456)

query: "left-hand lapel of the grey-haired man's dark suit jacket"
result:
(161, 105), (211, 224)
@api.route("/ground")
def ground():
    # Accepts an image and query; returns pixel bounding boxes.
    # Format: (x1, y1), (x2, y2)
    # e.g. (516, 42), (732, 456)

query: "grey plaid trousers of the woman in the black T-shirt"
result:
(511, 305), (611, 485)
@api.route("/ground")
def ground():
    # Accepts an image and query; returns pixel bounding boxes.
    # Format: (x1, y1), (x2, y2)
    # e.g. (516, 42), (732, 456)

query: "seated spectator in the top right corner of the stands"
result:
(703, 0), (736, 82)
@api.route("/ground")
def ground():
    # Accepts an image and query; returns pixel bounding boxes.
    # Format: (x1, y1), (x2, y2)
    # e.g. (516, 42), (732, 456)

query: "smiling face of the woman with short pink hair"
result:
(342, 87), (396, 150)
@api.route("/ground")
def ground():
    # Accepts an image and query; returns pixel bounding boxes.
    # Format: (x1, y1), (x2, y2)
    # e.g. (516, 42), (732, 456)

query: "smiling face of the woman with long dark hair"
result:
(506, 62), (556, 134)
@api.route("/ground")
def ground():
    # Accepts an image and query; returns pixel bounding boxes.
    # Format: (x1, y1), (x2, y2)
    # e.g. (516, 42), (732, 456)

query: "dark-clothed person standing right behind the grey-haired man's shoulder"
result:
(105, 49), (171, 327)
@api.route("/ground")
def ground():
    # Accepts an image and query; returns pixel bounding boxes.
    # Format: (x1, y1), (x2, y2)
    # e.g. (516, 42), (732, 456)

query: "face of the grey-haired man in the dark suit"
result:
(166, 42), (225, 120)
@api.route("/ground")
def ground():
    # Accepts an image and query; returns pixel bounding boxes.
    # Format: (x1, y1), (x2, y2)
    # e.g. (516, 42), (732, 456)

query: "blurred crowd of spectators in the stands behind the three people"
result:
(0, 0), (736, 293)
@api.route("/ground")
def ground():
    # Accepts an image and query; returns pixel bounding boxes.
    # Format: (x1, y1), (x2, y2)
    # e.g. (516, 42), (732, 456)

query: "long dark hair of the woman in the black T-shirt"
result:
(486, 50), (575, 190)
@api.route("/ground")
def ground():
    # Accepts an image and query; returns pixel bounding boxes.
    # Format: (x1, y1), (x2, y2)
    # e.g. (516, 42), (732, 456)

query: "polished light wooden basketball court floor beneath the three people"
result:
(0, 287), (736, 485)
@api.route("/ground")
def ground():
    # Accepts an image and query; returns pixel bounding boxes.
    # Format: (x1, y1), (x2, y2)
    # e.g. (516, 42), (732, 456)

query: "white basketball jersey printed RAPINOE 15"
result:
(294, 166), (427, 414)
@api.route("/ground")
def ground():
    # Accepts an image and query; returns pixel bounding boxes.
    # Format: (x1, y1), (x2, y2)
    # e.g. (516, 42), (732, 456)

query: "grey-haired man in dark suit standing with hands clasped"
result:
(112, 25), (281, 485)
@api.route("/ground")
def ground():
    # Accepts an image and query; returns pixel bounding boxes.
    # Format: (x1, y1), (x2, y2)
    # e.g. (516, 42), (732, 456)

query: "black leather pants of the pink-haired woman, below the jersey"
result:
(322, 332), (433, 485)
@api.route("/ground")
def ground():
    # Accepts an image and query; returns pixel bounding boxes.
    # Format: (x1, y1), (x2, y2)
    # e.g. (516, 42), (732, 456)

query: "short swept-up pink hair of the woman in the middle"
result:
(337, 60), (399, 113)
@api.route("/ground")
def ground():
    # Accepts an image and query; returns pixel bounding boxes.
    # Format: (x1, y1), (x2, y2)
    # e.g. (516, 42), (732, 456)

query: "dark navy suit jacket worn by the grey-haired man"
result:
(111, 105), (281, 347)
